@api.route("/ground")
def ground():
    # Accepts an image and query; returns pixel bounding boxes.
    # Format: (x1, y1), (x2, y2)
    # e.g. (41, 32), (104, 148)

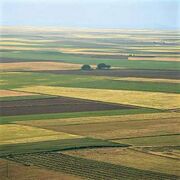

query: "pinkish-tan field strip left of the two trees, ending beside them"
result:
(0, 62), (81, 70)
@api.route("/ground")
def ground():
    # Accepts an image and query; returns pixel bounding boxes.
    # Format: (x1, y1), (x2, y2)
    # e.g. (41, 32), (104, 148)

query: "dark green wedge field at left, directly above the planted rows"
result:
(0, 138), (128, 157)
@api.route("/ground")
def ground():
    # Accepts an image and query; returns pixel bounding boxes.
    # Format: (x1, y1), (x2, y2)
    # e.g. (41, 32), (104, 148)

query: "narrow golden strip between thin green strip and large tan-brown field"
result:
(15, 112), (180, 126)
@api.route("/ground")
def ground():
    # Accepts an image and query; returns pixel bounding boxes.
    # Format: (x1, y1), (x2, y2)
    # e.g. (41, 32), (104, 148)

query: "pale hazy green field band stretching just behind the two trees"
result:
(1, 51), (180, 70)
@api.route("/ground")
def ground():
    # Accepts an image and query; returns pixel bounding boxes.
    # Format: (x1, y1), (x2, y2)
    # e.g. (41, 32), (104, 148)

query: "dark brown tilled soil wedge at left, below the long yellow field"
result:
(0, 97), (137, 116)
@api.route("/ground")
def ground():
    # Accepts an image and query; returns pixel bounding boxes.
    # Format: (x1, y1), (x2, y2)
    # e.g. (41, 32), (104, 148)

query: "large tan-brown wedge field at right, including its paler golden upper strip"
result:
(19, 114), (180, 139)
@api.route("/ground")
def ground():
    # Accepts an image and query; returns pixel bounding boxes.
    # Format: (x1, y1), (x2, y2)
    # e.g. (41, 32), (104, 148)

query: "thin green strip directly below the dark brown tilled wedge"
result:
(0, 108), (163, 124)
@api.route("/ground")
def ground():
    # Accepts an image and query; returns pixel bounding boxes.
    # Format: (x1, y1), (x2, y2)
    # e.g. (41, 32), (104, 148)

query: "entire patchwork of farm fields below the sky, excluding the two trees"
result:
(0, 27), (180, 180)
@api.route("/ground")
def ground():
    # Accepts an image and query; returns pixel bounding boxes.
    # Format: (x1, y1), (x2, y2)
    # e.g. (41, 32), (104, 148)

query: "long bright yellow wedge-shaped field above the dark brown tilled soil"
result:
(15, 86), (180, 109)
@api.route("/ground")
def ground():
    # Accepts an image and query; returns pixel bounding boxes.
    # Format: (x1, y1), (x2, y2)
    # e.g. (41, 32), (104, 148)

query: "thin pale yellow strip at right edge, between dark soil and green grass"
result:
(112, 77), (180, 84)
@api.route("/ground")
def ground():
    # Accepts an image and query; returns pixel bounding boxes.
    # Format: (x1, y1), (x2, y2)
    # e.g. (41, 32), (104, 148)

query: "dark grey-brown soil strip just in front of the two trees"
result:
(32, 69), (180, 79)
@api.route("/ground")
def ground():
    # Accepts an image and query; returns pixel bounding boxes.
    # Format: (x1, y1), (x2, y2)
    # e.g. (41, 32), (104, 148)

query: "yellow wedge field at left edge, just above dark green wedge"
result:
(0, 124), (81, 145)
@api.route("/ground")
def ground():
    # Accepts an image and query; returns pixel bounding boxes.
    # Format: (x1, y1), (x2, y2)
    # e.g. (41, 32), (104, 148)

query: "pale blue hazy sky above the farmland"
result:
(0, 0), (180, 29)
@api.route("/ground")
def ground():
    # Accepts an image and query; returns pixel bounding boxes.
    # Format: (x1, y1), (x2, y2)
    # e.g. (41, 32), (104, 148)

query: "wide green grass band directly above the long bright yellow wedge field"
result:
(0, 72), (180, 93)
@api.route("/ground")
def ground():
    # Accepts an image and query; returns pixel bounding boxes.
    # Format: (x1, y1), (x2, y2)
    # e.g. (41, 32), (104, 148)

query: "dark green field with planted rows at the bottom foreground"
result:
(6, 153), (178, 180)
